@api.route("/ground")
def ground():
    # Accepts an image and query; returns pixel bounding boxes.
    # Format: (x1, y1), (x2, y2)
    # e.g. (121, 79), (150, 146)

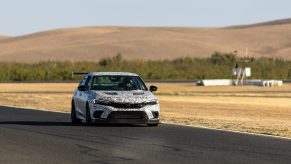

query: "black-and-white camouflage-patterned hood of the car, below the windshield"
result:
(93, 91), (157, 104)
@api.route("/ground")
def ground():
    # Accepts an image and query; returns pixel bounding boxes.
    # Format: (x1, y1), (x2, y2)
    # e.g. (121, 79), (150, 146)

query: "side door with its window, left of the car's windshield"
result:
(74, 75), (91, 116)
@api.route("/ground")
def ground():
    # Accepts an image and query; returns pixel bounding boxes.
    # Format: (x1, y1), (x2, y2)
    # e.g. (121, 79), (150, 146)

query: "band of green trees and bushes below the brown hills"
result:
(0, 52), (291, 82)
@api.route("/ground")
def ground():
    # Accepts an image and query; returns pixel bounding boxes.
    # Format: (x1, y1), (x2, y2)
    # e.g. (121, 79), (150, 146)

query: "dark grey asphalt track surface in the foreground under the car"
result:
(0, 107), (291, 164)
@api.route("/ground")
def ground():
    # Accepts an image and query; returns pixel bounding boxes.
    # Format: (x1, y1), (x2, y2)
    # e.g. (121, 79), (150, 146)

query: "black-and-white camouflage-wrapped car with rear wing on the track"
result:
(71, 72), (160, 126)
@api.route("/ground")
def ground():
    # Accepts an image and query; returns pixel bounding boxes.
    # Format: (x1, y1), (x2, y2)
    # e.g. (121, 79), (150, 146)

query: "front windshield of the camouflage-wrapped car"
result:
(91, 75), (147, 91)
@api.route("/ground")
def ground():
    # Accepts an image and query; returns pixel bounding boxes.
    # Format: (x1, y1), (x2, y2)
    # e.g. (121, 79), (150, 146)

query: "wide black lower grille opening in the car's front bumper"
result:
(108, 111), (147, 119)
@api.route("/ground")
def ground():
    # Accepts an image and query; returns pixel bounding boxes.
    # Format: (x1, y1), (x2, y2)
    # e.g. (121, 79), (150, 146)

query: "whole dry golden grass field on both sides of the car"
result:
(0, 83), (291, 137)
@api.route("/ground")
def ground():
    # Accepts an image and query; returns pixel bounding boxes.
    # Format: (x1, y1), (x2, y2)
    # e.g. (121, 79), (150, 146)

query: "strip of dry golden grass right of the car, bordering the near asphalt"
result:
(159, 96), (291, 137)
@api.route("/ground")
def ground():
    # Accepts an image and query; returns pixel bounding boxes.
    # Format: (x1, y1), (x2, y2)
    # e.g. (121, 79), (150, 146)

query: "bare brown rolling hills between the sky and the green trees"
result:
(0, 19), (291, 63)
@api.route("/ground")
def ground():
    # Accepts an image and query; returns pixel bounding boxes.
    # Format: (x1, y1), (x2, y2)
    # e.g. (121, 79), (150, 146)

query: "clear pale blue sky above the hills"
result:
(0, 0), (291, 36)
